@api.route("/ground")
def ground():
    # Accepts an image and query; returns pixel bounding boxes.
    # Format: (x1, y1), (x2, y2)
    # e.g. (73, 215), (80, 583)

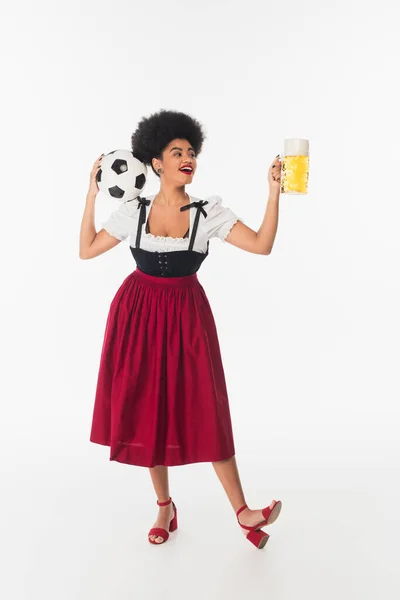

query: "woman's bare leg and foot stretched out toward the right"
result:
(212, 456), (273, 535)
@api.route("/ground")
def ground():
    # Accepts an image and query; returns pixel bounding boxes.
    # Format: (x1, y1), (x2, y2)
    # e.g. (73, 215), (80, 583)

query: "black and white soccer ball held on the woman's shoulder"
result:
(96, 150), (147, 202)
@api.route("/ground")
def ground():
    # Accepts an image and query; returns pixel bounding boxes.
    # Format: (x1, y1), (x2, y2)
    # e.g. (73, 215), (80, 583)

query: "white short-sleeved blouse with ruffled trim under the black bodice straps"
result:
(102, 194), (243, 253)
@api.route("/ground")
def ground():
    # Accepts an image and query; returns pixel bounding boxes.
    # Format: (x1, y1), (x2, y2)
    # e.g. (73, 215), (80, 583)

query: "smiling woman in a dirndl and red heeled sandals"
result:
(80, 110), (281, 548)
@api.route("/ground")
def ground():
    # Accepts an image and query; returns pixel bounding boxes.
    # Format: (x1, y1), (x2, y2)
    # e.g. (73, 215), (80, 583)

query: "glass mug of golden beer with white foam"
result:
(281, 139), (310, 194)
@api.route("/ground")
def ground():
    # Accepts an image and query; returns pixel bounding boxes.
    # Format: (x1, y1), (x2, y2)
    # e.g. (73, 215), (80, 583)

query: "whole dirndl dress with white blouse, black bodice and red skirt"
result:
(90, 195), (242, 467)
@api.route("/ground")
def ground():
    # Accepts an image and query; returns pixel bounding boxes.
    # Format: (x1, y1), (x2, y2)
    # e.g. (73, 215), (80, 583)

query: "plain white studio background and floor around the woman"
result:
(0, 0), (400, 600)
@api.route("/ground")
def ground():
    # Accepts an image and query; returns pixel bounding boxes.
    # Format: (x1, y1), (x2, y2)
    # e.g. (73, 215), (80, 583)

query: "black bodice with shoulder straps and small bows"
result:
(129, 196), (209, 277)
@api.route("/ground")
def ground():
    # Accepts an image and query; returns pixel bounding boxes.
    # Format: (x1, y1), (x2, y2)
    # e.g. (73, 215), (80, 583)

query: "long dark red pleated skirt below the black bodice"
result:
(90, 268), (235, 467)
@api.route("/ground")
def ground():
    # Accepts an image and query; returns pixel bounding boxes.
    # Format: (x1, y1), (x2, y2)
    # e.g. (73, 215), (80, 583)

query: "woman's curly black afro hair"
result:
(131, 109), (206, 177)
